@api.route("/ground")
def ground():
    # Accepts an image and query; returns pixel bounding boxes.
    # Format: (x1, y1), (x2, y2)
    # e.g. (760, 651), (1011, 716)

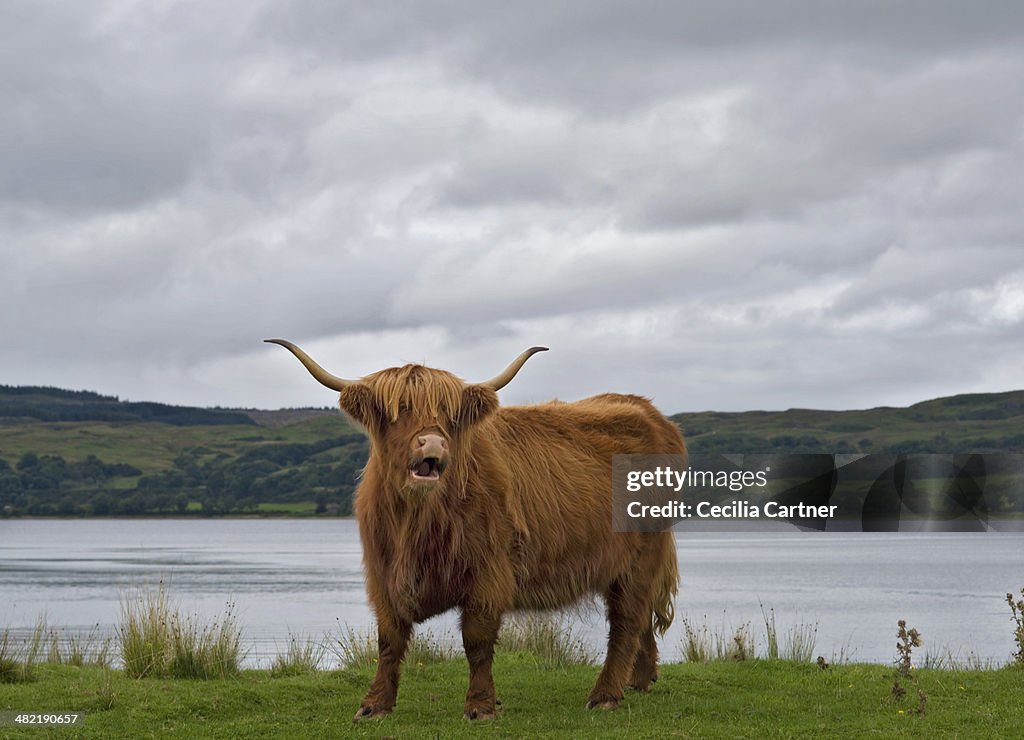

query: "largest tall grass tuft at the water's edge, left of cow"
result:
(118, 582), (243, 679)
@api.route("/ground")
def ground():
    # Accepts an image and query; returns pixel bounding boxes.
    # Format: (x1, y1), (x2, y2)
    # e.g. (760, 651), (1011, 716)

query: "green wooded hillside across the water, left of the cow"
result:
(0, 387), (368, 516)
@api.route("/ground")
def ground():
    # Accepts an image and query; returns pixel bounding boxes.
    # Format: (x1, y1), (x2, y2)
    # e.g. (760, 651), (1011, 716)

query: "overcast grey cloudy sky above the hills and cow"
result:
(0, 0), (1024, 412)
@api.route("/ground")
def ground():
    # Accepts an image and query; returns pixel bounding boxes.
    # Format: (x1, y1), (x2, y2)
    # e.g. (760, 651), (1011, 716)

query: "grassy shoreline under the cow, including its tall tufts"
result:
(0, 585), (1024, 738)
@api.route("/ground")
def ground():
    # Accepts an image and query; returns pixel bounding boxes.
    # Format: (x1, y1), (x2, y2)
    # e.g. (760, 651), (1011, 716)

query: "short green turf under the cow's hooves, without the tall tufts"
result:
(0, 653), (1024, 738)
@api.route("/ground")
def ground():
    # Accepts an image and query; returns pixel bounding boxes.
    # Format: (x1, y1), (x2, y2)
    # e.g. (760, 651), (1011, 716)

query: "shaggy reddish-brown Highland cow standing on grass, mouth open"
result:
(267, 340), (685, 720)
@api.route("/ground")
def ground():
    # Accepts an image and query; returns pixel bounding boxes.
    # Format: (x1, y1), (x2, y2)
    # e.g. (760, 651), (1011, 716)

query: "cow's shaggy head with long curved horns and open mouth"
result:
(266, 339), (547, 492)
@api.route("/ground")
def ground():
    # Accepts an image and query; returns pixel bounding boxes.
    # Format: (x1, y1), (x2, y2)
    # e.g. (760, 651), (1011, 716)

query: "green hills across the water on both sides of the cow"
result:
(0, 386), (1024, 516)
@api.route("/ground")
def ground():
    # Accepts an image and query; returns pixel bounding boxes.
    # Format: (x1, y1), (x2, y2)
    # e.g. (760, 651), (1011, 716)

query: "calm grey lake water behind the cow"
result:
(0, 519), (1024, 667)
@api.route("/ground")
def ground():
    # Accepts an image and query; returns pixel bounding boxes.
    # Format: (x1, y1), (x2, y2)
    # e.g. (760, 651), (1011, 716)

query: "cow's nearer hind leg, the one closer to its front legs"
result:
(587, 580), (653, 709)
